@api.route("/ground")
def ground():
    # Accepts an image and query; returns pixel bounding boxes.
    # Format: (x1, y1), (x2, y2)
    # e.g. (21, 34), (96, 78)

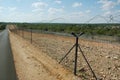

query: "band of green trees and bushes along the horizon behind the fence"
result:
(17, 23), (120, 36)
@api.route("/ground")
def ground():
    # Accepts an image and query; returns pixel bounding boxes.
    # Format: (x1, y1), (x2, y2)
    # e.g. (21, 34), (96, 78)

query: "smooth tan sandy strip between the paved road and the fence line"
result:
(10, 32), (80, 80)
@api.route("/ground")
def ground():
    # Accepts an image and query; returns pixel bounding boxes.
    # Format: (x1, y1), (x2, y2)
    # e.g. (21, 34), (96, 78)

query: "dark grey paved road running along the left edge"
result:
(0, 29), (17, 80)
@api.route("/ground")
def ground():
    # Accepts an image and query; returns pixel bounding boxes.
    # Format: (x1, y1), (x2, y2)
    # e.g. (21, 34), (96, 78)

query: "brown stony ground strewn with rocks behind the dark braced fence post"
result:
(14, 32), (120, 80)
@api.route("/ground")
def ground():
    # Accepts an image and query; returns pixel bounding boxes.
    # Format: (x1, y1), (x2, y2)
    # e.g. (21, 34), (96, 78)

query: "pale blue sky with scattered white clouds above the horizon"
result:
(0, 0), (120, 23)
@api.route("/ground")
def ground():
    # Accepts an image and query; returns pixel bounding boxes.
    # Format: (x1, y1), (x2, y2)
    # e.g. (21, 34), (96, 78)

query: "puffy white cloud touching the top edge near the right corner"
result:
(98, 0), (116, 10)
